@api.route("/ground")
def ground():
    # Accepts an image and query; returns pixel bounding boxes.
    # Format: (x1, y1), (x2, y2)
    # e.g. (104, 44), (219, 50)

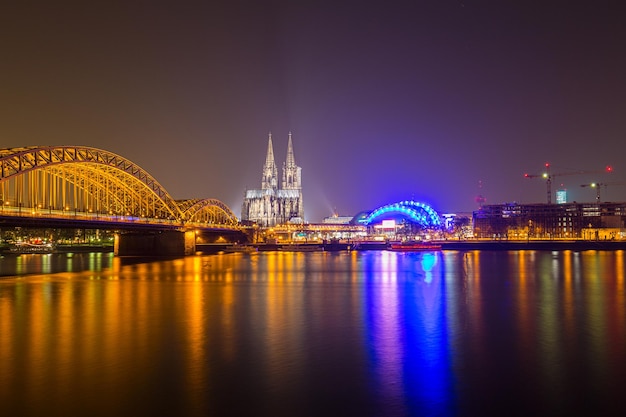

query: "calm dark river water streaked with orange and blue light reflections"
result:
(0, 251), (626, 417)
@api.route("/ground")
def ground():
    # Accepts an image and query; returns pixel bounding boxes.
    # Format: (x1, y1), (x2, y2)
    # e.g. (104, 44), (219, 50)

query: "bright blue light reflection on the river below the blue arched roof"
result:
(363, 252), (455, 415)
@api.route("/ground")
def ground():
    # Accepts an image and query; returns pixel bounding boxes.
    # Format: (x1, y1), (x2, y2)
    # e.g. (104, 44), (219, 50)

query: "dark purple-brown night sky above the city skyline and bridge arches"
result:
(0, 0), (626, 222)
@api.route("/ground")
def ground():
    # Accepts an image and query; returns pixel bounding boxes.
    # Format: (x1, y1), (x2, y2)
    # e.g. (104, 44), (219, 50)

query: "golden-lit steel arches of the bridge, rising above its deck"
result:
(0, 146), (239, 226)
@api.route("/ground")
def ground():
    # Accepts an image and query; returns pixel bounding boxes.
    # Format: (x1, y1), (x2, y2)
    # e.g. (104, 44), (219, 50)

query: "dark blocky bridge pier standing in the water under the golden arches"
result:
(114, 230), (196, 256)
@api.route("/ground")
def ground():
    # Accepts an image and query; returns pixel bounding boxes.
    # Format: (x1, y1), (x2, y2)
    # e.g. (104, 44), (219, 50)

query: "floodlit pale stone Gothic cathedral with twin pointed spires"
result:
(241, 132), (304, 227)
